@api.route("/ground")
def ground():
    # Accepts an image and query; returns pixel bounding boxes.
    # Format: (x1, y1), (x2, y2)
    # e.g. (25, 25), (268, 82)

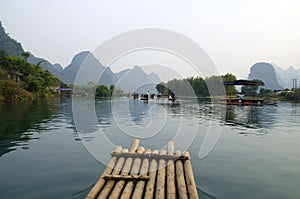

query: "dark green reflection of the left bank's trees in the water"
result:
(0, 100), (59, 156)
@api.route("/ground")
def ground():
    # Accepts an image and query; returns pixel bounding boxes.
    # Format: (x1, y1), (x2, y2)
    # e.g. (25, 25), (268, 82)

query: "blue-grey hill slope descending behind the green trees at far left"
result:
(0, 21), (60, 77)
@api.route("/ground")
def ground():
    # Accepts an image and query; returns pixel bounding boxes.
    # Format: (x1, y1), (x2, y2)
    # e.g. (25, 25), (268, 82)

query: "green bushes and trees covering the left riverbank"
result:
(0, 51), (60, 101)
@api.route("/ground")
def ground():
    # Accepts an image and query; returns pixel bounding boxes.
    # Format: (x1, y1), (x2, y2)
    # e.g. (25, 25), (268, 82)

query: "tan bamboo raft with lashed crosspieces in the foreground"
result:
(86, 139), (198, 199)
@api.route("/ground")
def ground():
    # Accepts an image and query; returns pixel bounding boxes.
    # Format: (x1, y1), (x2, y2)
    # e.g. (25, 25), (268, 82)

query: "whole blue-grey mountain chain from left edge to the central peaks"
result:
(0, 21), (160, 88)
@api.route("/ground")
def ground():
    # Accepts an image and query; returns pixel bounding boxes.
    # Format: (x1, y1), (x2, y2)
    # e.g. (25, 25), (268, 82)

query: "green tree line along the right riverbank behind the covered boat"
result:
(156, 73), (300, 101)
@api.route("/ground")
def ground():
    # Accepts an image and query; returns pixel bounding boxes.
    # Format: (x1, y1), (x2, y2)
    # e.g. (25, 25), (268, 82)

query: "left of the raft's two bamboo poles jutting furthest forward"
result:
(109, 139), (139, 199)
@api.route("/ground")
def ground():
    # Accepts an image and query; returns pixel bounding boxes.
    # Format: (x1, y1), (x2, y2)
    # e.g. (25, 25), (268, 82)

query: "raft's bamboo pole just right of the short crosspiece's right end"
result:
(145, 150), (158, 199)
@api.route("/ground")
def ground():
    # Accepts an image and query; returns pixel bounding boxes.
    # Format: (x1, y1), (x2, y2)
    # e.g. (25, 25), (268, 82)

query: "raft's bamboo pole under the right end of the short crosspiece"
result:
(132, 149), (151, 199)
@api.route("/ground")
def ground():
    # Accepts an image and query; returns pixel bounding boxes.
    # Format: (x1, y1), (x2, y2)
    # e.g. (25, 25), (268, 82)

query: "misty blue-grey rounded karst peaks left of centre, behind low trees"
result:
(61, 51), (161, 92)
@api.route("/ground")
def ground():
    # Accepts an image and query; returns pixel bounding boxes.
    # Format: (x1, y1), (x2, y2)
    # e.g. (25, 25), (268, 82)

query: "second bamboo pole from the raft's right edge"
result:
(175, 150), (188, 199)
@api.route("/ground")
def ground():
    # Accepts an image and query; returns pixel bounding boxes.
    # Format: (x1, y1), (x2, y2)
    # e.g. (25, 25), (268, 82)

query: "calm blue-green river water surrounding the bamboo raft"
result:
(0, 98), (300, 199)
